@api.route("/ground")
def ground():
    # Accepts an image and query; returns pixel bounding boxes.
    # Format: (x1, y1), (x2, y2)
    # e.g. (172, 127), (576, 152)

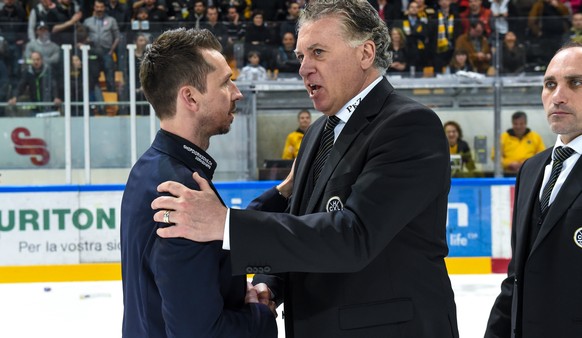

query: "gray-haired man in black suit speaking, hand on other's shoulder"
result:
(152, 0), (458, 338)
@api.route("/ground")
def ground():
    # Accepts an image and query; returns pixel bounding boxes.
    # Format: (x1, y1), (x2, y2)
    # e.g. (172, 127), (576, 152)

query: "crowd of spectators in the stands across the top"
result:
(0, 0), (582, 115)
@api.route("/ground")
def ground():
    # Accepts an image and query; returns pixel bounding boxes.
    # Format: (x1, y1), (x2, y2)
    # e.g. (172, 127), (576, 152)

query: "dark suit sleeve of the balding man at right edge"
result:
(485, 167), (523, 338)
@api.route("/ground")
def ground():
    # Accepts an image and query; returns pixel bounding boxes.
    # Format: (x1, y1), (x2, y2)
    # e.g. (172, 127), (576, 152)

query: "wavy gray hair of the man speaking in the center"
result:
(297, 0), (392, 74)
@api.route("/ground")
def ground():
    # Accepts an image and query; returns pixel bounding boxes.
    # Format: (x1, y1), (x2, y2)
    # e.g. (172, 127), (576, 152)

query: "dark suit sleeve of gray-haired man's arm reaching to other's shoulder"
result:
(230, 101), (450, 273)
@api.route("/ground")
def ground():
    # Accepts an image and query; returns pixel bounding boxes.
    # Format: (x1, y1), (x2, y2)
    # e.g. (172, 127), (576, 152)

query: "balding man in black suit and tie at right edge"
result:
(485, 44), (582, 338)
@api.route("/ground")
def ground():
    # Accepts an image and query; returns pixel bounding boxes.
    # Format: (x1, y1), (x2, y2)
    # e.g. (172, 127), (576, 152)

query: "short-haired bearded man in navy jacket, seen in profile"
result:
(121, 28), (277, 338)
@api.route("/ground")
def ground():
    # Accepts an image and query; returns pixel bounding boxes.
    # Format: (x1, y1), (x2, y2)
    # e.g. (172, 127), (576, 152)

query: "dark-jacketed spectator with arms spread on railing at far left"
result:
(8, 52), (62, 113)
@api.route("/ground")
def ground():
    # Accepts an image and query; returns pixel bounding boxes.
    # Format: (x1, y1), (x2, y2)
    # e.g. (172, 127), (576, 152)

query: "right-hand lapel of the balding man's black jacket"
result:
(532, 154), (582, 251)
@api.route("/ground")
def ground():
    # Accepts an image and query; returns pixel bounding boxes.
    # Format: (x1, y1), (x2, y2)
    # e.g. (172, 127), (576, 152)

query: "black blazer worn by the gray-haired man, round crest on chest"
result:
(230, 79), (458, 338)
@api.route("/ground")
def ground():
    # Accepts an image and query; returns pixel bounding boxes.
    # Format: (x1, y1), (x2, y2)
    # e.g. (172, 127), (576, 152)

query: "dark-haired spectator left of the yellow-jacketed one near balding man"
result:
(443, 121), (475, 177)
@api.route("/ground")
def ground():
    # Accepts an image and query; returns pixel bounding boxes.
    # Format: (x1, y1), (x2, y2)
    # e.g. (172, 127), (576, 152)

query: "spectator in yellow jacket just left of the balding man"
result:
(492, 111), (546, 176)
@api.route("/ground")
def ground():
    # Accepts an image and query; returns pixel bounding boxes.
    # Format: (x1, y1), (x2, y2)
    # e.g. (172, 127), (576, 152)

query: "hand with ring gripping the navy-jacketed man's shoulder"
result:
(151, 173), (226, 242)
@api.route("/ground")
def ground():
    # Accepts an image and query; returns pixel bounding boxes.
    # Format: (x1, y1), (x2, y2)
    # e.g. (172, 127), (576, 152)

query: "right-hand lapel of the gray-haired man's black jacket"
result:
(306, 78), (394, 213)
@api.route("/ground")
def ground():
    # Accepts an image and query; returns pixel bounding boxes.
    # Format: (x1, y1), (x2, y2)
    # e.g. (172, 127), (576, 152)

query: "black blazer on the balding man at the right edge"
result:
(485, 148), (582, 338)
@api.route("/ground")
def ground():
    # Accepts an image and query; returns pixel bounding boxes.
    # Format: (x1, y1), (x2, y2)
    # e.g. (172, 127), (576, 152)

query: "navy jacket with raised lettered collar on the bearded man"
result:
(121, 130), (277, 338)
